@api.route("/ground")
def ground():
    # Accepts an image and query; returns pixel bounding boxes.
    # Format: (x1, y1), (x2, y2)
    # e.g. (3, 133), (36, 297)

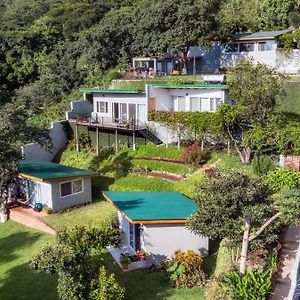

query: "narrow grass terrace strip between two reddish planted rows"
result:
(132, 159), (191, 174)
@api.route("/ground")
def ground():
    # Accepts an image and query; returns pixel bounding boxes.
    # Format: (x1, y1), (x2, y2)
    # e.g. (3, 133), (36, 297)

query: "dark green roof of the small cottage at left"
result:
(19, 160), (97, 181)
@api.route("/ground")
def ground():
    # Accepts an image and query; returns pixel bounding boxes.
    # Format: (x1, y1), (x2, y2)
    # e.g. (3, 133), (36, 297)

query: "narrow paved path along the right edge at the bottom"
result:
(271, 225), (300, 300)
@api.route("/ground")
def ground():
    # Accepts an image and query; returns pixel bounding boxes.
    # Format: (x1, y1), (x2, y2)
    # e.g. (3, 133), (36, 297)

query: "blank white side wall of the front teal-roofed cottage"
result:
(143, 224), (208, 258)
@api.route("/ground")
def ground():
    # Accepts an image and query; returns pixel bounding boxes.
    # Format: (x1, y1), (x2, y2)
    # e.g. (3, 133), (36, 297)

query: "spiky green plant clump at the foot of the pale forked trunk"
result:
(224, 269), (272, 300)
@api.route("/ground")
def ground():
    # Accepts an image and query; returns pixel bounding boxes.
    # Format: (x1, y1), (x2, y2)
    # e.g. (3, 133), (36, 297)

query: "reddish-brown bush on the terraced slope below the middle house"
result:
(181, 143), (211, 167)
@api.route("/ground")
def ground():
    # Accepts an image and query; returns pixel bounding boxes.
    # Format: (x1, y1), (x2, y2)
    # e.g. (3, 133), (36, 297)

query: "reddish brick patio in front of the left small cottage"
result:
(9, 207), (56, 234)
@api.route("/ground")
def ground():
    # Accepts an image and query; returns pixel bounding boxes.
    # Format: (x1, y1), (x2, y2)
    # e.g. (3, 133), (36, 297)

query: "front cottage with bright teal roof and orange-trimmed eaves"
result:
(103, 192), (208, 262)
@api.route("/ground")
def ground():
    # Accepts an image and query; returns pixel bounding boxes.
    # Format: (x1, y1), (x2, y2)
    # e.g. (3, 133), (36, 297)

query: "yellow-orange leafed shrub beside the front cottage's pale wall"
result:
(167, 250), (205, 288)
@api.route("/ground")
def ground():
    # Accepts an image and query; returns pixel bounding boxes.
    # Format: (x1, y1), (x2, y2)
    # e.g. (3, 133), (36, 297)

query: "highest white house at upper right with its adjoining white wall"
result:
(220, 29), (300, 74)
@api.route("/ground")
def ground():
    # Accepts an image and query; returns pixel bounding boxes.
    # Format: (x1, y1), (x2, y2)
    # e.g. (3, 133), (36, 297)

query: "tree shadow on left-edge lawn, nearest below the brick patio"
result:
(0, 232), (41, 262)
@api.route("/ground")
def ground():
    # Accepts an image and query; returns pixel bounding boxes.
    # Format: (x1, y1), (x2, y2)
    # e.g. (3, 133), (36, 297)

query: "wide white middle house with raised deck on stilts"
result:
(67, 84), (230, 149)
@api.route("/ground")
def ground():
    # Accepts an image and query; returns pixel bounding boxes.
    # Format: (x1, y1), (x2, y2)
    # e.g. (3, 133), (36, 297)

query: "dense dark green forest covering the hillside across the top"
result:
(0, 0), (299, 123)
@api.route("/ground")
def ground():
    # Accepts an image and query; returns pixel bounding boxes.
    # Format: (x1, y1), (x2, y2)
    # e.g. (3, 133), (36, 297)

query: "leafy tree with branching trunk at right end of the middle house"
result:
(218, 60), (285, 163)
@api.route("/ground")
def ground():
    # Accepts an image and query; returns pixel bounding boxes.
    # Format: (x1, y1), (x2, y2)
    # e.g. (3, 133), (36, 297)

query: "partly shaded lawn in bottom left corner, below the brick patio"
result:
(0, 221), (57, 300)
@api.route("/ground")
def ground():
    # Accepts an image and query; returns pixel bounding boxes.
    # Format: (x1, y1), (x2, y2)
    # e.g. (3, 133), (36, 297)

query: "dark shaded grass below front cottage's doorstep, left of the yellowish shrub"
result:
(101, 252), (174, 300)
